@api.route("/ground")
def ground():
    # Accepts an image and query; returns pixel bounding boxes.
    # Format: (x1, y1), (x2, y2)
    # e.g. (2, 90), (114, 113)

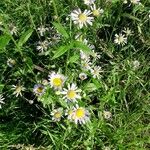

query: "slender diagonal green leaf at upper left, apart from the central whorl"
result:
(18, 29), (33, 47)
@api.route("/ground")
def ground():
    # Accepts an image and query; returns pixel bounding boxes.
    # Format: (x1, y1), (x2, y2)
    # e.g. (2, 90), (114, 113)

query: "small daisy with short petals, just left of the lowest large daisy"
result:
(51, 108), (63, 121)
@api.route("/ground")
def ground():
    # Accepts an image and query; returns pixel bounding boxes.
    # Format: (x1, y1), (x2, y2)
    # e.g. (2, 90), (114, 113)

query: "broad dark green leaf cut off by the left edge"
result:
(0, 34), (11, 49)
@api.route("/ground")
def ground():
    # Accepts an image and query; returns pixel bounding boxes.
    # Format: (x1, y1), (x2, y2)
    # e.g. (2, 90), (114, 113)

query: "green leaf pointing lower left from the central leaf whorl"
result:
(52, 44), (73, 59)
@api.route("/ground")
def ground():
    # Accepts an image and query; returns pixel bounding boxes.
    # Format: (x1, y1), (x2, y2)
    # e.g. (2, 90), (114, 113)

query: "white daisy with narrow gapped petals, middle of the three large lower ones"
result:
(61, 83), (81, 102)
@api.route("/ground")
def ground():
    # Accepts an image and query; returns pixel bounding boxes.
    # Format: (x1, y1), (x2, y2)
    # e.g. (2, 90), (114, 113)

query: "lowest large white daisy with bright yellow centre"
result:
(70, 105), (90, 124)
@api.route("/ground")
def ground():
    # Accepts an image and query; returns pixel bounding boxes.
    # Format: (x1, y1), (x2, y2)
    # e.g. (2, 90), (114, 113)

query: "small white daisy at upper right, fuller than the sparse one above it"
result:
(114, 33), (127, 45)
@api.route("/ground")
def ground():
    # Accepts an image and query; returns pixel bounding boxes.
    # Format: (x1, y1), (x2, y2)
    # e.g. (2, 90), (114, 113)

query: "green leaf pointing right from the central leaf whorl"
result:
(74, 41), (92, 55)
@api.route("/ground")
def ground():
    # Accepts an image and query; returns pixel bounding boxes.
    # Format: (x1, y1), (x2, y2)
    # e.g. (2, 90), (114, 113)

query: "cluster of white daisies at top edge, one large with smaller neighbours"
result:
(70, 0), (104, 28)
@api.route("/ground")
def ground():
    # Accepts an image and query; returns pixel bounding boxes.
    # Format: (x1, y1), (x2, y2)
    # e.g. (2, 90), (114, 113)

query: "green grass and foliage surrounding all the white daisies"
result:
(0, 0), (150, 150)
